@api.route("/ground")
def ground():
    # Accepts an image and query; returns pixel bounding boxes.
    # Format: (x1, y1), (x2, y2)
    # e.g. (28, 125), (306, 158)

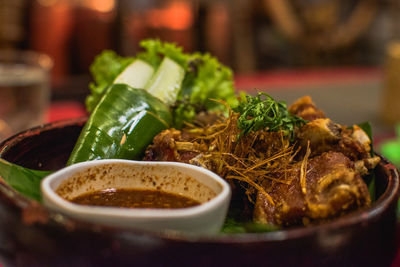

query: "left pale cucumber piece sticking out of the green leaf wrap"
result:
(113, 59), (154, 89)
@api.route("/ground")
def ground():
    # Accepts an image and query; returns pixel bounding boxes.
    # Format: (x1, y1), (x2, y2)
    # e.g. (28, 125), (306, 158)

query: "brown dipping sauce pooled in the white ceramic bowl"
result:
(70, 189), (200, 209)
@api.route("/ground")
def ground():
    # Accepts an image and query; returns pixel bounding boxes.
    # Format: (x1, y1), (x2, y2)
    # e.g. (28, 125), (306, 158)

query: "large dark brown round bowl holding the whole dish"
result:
(0, 118), (399, 266)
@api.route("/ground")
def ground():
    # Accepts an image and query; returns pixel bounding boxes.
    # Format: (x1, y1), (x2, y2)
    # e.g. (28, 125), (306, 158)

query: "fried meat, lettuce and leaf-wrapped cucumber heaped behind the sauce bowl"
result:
(0, 40), (386, 234)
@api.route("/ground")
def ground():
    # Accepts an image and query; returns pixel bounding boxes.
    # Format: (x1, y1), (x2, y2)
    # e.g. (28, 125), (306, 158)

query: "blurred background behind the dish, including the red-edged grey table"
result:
(0, 0), (400, 161)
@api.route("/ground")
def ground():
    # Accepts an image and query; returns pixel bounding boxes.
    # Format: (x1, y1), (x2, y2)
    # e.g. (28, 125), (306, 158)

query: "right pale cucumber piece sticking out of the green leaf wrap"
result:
(145, 57), (185, 105)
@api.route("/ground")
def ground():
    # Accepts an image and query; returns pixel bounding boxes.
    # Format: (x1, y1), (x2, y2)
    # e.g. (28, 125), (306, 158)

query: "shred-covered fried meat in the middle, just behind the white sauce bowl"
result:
(144, 114), (290, 177)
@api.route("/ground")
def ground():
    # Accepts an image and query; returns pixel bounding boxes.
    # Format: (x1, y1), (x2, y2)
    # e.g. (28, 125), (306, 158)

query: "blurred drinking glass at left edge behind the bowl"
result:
(0, 50), (53, 141)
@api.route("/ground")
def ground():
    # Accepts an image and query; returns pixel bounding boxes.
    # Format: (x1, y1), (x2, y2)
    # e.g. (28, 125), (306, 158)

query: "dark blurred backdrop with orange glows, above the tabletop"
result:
(0, 0), (400, 83)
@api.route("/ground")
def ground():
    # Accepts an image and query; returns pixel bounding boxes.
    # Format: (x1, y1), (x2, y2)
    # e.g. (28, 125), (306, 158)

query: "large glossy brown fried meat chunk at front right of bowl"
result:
(254, 152), (370, 226)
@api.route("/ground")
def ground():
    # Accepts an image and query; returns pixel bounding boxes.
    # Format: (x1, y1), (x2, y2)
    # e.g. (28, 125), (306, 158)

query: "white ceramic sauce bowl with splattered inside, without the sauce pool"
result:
(41, 159), (231, 234)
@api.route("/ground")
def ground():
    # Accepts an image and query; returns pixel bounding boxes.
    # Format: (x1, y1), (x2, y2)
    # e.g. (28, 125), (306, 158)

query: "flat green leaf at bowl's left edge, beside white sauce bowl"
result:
(0, 158), (51, 201)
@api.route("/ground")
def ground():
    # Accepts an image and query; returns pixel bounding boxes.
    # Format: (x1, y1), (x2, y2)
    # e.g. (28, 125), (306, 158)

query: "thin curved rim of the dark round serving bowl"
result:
(0, 117), (400, 243)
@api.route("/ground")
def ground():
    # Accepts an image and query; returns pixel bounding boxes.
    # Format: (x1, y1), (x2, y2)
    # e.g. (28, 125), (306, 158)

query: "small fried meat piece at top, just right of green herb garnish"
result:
(289, 96), (326, 121)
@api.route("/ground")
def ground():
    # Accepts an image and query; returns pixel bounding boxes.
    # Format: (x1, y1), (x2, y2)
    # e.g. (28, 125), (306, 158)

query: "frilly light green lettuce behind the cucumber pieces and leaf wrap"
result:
(86, 39), (238, 128)
